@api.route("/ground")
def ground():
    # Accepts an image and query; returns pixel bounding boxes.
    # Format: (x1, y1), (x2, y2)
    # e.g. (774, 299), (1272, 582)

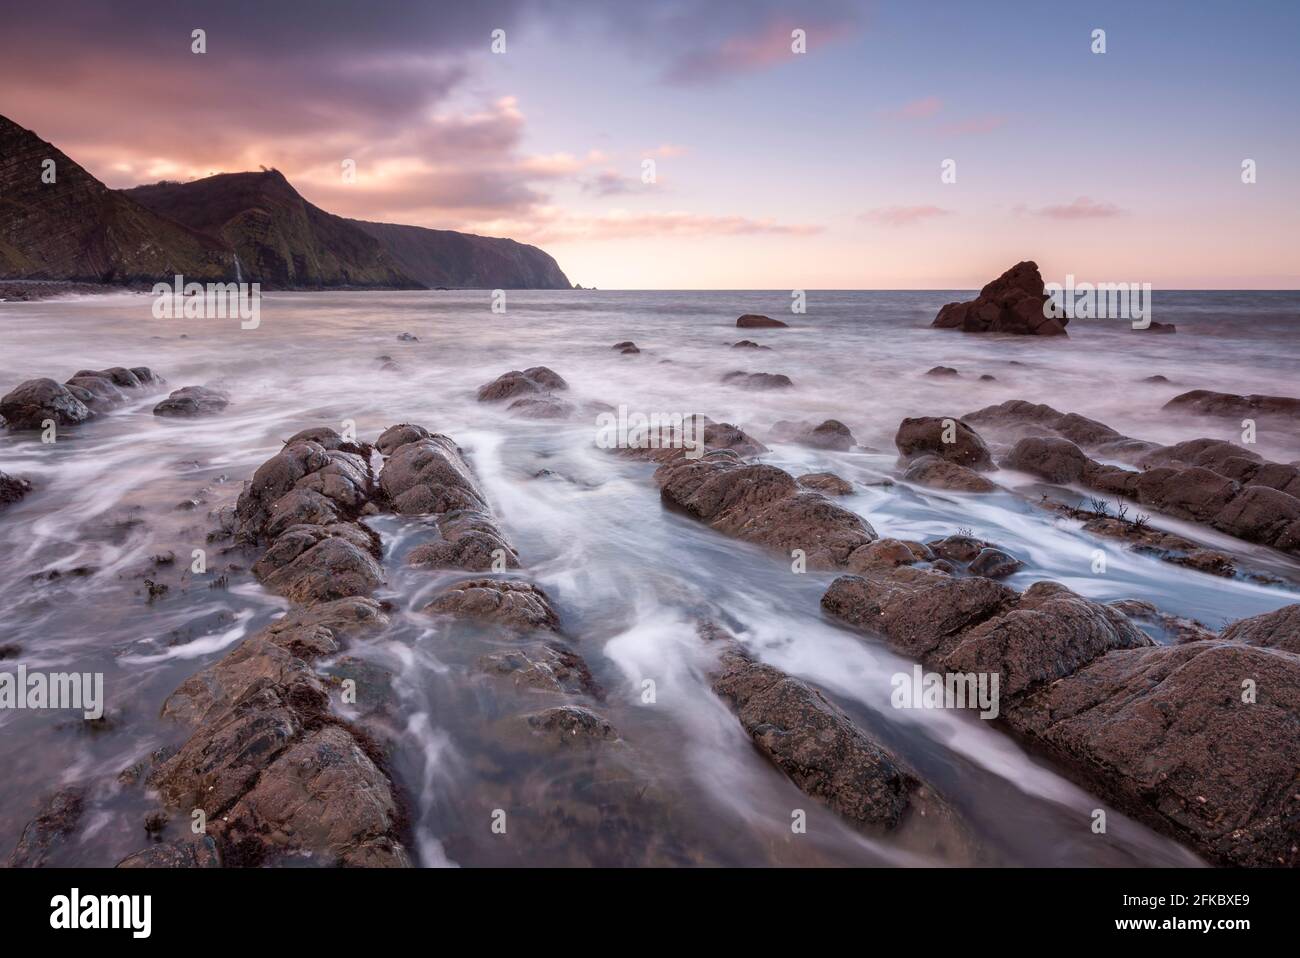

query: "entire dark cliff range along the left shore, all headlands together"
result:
(0, 116), (571, 290)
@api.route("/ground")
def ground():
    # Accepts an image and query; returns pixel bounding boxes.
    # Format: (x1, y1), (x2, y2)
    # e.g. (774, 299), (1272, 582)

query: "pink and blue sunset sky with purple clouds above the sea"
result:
(0, 0), (1300, 290)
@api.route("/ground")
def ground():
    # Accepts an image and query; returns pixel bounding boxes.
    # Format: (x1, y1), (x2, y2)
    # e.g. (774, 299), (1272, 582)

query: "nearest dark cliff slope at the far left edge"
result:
(0, 116), (234, 283)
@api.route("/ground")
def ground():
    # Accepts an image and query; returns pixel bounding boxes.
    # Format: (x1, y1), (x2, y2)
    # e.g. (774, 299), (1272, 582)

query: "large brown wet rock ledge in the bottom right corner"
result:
(822, 567), (1300, 864)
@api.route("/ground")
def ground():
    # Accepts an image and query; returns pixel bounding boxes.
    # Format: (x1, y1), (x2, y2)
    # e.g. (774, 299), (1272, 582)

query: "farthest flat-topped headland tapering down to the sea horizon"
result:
(348, 220), (573, 290)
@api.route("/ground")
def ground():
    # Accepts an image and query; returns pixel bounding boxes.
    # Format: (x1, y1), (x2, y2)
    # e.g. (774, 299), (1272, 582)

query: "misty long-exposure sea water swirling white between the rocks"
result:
(0, 291), (1300, 866)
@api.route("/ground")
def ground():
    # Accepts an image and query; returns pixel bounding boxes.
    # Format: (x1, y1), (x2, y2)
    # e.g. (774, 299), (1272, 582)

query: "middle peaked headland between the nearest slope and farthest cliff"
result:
(122, 170), (421, 289)
